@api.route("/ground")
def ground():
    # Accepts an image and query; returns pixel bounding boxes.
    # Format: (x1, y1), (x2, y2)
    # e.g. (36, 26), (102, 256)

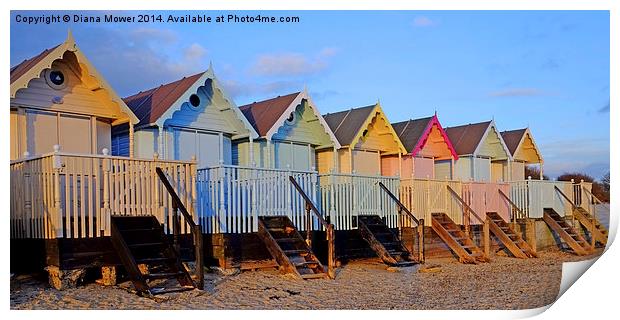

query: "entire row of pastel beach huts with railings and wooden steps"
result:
(10, 33), (607, 294)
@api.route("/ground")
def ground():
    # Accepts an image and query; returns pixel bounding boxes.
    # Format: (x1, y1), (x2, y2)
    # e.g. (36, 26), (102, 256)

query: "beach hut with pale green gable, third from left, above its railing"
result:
(233, 90), (340, 171)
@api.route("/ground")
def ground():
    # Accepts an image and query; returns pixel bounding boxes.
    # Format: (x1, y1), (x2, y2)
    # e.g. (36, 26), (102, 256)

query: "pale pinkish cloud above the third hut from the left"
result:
(250, 47), (338, 76)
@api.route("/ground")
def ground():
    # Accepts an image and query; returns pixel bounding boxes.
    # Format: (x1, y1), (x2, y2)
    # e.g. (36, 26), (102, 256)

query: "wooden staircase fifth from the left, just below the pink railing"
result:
(487, 212), (538, 259)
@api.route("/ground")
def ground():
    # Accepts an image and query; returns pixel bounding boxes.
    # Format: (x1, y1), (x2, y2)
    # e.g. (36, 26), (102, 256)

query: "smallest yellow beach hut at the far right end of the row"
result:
(501, 128), (543, 181)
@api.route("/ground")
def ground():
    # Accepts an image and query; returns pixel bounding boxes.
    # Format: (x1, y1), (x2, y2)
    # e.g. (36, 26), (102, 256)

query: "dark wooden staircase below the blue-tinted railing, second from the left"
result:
(258, 216), (329, 279)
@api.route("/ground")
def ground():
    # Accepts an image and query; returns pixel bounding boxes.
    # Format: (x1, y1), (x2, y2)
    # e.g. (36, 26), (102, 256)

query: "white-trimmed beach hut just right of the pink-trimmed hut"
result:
(446, 121), (511, 182)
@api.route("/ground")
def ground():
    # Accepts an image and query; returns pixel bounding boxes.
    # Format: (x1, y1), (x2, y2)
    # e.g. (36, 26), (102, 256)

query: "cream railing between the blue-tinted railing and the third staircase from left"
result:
(319, 173), (399, 230)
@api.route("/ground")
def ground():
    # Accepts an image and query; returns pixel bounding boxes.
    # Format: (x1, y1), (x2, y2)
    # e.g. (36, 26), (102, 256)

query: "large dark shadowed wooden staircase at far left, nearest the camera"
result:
(111, 216), (196, 296)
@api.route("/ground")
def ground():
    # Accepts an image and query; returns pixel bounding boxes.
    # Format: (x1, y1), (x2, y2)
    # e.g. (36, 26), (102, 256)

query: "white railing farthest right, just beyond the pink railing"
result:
(510, 179), (575, 218)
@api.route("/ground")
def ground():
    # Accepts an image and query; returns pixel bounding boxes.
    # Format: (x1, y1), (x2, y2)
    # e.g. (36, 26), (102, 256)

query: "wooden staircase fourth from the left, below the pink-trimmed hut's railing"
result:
(432, 213), (489, 264)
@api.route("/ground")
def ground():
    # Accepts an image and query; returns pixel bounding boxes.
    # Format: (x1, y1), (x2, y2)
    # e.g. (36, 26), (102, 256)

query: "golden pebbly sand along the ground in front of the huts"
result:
(10, 251), (600, 309)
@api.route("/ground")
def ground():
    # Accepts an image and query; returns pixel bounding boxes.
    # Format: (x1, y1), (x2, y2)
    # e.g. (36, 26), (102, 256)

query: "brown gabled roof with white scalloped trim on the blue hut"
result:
(123, 65), (258, 138)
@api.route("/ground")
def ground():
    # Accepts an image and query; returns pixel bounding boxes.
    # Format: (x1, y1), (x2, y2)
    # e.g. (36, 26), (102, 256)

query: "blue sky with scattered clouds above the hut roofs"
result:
(10, 11), (610, 179)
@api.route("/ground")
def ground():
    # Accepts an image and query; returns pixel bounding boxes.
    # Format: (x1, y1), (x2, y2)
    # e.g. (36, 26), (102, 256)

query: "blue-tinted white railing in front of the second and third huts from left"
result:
(197, 165), (318, 233)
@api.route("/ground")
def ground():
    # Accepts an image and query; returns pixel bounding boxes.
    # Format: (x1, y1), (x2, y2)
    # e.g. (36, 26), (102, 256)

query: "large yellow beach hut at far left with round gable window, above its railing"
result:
(10, 32), (138, 160)
